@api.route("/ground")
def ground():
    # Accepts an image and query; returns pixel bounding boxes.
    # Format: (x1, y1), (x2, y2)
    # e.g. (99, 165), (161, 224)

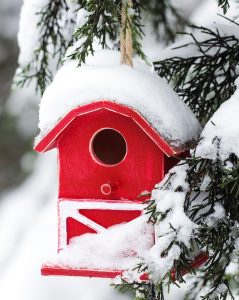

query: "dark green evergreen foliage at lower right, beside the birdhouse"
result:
(116, 151), (239, 300)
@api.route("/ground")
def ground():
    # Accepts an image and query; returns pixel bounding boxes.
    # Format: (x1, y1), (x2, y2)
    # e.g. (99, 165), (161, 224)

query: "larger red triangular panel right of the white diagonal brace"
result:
(79, 209), (142, 228)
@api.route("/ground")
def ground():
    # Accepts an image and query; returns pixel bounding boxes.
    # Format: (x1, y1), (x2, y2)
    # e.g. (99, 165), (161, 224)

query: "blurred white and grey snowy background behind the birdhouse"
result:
(0, 0), (236, 300)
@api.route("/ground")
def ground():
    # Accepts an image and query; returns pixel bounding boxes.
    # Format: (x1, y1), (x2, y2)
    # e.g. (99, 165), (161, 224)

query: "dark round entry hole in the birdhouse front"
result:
(92, 128), (127, 165)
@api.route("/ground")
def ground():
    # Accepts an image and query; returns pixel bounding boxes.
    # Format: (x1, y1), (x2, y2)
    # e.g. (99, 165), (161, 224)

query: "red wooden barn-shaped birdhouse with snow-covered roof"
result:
(35, 52), (200, 277)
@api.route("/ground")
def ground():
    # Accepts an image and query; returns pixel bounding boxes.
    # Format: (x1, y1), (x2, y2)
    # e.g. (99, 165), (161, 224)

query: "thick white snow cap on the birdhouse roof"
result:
(39, 50), (201, 147)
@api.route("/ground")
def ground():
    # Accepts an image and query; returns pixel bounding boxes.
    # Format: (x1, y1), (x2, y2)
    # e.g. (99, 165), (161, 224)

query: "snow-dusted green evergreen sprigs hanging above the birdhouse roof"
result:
(15, 0), (191, 94)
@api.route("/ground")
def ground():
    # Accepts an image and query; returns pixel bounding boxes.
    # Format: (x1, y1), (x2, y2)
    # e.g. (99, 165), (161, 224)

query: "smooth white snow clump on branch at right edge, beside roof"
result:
(196, 79), (239, 160)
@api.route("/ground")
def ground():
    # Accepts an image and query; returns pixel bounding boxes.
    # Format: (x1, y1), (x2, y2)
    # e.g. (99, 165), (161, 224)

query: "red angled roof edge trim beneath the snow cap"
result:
(34, 100), (183, 156)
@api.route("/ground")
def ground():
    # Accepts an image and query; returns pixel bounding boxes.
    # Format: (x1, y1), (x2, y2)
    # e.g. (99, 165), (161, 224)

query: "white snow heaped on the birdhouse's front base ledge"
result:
(46, 216), (154, 270)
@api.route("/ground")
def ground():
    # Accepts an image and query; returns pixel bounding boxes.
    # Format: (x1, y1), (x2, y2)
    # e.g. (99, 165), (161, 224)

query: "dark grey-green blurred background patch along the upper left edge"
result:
(0, 0), (37, 194)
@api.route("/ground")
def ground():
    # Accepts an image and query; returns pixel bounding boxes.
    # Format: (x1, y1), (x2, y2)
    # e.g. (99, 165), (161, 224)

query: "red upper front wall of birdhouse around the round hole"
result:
(58, 109), (164, 201)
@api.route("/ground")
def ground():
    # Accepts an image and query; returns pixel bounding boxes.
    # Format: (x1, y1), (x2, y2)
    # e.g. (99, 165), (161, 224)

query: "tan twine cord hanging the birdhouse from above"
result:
(120, 0), (133, 67)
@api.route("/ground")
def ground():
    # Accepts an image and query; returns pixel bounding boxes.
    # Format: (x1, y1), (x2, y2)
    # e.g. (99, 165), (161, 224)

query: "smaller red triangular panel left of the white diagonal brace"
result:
(66, 218), (97, 244)
